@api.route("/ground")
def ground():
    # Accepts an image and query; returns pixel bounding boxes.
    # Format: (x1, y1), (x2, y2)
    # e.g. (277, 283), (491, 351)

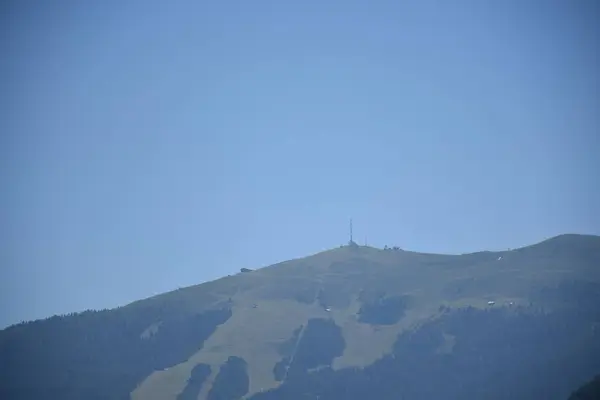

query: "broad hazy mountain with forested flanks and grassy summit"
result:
(0, 235), (600, 400)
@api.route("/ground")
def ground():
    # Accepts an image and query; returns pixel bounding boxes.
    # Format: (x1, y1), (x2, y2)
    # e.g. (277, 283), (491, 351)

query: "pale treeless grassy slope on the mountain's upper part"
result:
(129, 235), (600, 400)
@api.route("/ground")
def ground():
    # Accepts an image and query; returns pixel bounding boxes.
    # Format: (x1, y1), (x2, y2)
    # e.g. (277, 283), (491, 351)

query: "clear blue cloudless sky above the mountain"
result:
(0, 0), (600, 326)
